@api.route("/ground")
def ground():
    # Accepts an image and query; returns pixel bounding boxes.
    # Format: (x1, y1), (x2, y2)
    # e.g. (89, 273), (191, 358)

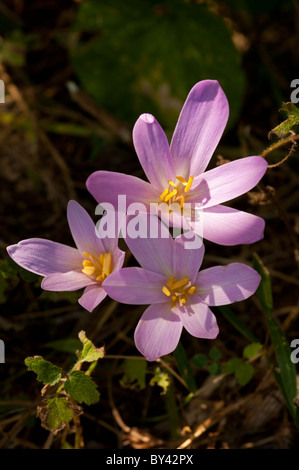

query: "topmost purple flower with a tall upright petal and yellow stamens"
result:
(86, 80), (267, 245)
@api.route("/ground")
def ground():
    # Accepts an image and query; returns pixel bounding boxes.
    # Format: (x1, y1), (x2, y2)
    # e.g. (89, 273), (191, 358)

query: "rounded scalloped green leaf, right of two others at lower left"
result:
(64, 370), (100, 405)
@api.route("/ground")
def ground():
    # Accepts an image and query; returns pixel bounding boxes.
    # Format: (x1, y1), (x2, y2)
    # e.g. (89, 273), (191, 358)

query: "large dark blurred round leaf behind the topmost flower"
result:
(70, 0), (245, 130)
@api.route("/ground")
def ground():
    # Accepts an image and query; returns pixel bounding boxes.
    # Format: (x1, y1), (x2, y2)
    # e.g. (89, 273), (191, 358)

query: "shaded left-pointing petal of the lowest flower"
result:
(102, 267), (169, 305)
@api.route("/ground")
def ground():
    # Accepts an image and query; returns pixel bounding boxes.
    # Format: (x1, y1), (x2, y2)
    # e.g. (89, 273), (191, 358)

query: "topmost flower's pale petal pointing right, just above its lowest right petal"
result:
(188, 156), (268, 209)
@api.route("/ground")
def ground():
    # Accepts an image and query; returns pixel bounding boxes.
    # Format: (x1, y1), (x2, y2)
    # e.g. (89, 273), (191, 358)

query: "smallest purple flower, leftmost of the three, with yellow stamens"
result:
(7, 201), (125, 312)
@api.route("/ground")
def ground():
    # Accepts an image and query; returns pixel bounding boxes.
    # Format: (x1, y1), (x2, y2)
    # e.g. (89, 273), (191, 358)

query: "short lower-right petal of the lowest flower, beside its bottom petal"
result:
(175, 294), (219, 339)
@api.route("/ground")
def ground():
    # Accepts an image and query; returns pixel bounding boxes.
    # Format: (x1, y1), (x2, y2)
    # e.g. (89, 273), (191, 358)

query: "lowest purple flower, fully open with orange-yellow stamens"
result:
(103, 216), (260, 361)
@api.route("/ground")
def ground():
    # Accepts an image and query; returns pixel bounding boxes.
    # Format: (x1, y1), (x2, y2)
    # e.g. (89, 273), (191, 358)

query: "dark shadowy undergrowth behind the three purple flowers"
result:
(0, 0), (299, 449)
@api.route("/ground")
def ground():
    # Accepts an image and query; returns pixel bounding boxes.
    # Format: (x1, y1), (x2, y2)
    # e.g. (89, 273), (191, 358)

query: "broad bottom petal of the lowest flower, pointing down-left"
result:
(134, 302), (183, 361)
